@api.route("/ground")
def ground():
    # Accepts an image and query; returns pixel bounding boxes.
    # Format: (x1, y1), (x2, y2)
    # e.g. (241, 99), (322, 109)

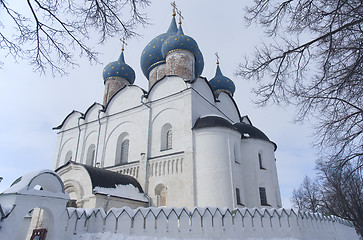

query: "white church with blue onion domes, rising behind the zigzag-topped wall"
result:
(53, 9), (281, 212)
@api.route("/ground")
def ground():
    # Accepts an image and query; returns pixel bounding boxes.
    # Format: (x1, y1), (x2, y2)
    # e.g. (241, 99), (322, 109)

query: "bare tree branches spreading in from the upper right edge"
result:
(237, 0), (363, 171)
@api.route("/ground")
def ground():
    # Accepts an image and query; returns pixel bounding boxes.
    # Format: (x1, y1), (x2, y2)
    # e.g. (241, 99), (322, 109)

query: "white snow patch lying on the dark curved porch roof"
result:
(93, 184), (148, 202)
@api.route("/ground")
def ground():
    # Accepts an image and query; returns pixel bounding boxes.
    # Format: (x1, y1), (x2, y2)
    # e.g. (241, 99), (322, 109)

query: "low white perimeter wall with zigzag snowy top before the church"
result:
(59, 207), (358, 240)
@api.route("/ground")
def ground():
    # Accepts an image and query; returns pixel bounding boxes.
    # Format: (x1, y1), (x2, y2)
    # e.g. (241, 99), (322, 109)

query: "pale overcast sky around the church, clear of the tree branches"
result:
(0, 0), (315, 207)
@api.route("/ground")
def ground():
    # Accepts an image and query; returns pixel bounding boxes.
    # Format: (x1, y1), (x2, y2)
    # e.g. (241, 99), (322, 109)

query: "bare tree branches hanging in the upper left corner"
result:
(0, 0), (150, 74)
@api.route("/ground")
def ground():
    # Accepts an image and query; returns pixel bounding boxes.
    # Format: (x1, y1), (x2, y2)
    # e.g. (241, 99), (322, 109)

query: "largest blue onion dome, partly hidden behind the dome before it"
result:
(140, 15), (178, 79)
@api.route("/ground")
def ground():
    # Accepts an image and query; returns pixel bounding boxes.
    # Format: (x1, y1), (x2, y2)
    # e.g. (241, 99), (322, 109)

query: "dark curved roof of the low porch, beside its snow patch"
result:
(55, 161), (144, 193)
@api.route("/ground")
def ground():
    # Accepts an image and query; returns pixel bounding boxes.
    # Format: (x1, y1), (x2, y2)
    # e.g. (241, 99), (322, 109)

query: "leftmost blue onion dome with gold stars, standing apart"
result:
(103, 49), (135, 84)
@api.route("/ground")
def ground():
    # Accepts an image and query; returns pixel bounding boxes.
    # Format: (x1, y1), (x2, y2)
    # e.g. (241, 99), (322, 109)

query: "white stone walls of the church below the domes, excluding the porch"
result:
(53, 71), (281, 208)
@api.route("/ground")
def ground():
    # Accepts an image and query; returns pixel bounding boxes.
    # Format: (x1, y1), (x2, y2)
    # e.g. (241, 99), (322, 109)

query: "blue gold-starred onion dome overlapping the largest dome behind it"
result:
(161, 23), (204, 77)
